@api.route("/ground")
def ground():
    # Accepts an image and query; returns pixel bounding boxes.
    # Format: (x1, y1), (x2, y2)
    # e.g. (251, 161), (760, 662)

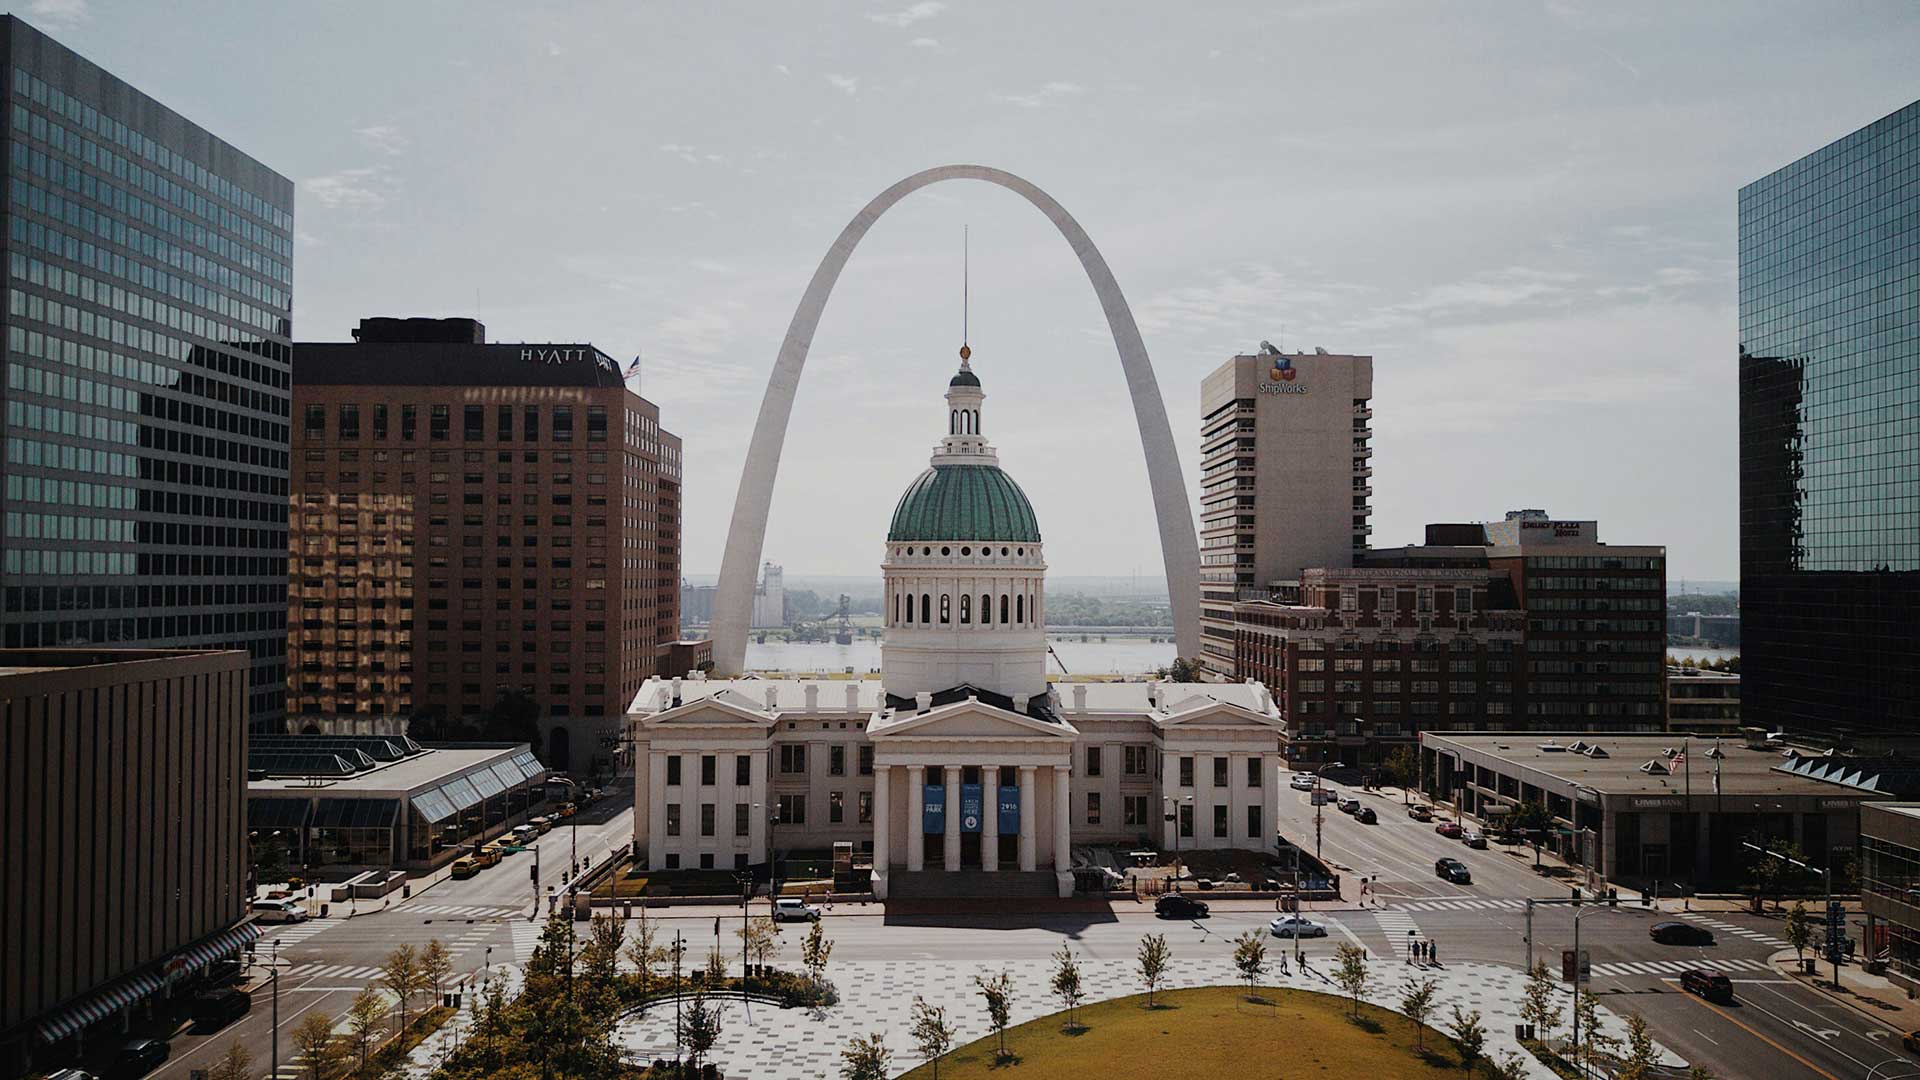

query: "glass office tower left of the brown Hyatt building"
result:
(0, 17), (294, 723)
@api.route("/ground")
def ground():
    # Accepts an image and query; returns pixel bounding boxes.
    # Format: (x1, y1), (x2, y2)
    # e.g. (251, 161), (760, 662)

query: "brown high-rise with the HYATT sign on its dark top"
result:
(288, 319), (682, 773)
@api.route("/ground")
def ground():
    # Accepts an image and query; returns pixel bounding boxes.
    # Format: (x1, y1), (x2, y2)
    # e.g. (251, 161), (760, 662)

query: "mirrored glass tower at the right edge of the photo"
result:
(1740, 102), (1920, 734)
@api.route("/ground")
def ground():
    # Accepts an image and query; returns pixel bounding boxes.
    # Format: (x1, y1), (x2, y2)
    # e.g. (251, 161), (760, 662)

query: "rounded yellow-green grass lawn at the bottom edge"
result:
(897, 986), (1465, 1080)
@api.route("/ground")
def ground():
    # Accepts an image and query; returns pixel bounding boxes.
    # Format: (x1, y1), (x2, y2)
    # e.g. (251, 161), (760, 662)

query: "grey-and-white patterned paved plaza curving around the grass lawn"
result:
(614, 947), (1678, 1080)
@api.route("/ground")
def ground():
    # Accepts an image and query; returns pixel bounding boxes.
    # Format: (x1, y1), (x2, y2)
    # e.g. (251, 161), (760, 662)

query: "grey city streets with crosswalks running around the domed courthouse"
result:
(131, 772), (1920, 1080)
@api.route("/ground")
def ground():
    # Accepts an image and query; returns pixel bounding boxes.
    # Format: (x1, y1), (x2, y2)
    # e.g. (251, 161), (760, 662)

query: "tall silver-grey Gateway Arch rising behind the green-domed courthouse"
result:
(712, 165), (1200, 675)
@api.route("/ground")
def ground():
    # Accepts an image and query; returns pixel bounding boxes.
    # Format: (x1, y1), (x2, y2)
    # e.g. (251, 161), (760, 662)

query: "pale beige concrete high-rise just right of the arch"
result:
(1173, 346), (1373, 678)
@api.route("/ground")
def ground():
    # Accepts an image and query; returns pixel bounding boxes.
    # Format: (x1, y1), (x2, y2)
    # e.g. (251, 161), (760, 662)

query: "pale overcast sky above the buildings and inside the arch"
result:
(30, 0), (1920, 582)
